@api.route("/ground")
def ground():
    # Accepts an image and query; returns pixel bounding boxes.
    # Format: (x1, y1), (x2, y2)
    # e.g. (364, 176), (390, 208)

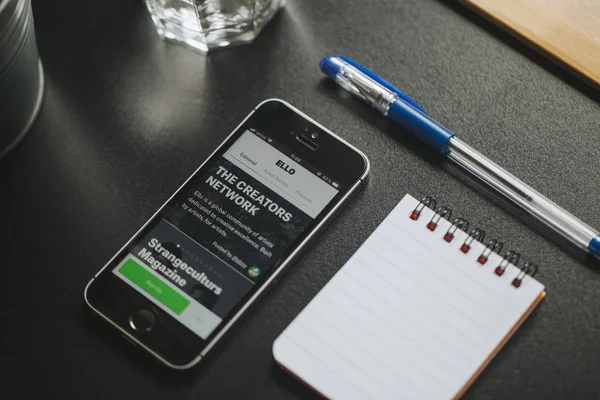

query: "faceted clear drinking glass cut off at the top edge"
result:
(145, 0), (285, 53)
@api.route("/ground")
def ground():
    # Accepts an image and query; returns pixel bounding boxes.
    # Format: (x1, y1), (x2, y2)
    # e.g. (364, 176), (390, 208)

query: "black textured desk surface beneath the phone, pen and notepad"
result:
(0, 0), (600, 400)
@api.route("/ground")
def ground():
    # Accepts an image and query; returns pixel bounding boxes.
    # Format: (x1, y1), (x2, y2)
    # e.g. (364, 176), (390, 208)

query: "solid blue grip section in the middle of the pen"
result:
(387, 99), (455, 154)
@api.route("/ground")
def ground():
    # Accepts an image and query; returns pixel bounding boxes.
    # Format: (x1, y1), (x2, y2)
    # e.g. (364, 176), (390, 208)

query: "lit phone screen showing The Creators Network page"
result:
(112, 129), (342, 339)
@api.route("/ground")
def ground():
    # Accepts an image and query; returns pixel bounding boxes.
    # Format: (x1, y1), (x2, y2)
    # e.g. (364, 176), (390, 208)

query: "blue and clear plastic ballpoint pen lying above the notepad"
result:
(319, 57), (600, 259)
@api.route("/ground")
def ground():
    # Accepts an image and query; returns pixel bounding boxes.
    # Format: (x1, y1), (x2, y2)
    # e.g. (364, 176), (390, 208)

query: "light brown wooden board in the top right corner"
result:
(459, 0), (600, 87)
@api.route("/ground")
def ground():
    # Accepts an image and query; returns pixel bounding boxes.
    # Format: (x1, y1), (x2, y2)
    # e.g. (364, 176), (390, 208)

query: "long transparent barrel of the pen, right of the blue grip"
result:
(448, 137), (598, 249)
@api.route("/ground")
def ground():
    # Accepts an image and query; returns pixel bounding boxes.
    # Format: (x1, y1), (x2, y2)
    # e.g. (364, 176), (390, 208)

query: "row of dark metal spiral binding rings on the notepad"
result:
(410, 196), (538, 288)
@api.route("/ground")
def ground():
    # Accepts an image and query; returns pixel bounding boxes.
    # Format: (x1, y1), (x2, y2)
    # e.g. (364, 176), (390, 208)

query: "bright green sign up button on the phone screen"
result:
(119, 258), (190, 315)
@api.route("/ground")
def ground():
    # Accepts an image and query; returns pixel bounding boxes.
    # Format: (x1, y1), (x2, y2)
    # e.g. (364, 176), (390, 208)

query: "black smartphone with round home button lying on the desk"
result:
(85, 99), (369, 369)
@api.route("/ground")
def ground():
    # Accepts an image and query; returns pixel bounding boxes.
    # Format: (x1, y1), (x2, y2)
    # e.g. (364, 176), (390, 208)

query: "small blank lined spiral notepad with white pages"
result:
(273, 195), (545, 400)
